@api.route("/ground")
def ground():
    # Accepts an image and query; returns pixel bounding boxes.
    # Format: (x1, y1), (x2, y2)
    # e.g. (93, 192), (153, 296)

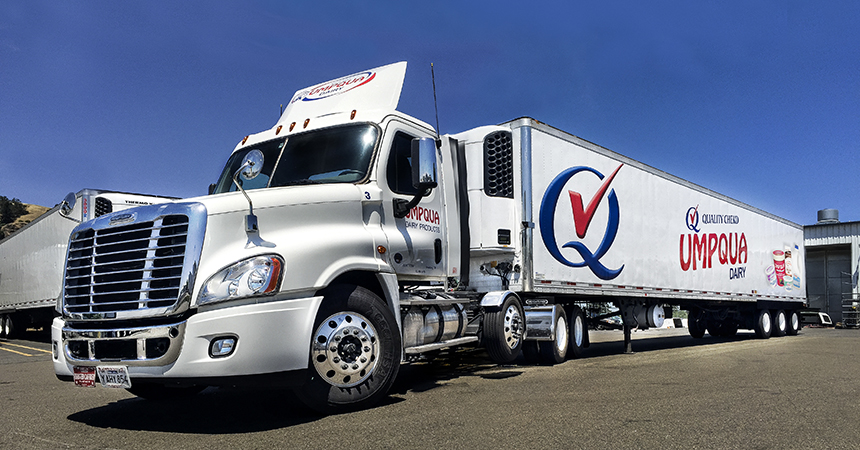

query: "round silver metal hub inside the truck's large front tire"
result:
(311, 312), (379, 388)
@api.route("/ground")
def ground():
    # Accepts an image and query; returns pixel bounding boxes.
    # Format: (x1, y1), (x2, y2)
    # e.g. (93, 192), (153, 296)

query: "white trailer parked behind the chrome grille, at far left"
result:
(0, 189), (169, 337)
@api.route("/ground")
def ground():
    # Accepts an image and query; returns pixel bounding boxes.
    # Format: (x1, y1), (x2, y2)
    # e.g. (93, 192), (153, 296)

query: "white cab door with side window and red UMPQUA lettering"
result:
(378, 121), (447, 282)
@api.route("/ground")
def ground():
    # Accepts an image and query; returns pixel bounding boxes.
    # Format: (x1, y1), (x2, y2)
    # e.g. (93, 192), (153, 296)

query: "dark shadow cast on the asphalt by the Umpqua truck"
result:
(68, 333), (755, 434)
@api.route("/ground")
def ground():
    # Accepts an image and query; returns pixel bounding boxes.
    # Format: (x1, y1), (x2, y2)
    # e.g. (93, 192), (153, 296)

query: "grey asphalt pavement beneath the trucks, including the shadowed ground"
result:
(0, 328), (860, 450)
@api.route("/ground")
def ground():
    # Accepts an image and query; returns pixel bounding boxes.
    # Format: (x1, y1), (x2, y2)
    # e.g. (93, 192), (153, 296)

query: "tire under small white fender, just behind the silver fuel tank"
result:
(483, 295), (526, 364)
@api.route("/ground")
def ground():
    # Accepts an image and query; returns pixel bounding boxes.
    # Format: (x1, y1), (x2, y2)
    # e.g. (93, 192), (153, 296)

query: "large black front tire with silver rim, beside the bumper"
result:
(295, 285), (402, 414)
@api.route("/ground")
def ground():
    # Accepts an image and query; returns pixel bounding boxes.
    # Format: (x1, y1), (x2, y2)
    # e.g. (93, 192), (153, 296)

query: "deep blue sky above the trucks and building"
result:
(0, 0), (860, 224)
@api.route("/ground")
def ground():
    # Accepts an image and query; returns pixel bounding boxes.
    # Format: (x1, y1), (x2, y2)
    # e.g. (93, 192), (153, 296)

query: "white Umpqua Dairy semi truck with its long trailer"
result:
(52, 62), (805, 412)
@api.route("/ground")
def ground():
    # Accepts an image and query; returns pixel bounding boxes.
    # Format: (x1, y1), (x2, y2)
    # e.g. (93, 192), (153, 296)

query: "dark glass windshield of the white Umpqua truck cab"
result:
(213, 124), (379, 194)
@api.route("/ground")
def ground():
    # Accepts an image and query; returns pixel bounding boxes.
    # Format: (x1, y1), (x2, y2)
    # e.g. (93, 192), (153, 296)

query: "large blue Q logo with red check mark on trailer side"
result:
(539, 164), (624, 280)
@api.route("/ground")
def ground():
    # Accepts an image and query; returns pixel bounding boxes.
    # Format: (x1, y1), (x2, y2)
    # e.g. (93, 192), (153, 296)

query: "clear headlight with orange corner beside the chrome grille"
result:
(197, 255), (284, 305)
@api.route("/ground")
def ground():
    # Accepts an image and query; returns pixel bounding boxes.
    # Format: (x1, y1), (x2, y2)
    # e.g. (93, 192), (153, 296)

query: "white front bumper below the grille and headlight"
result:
(51, 297), (322, 382)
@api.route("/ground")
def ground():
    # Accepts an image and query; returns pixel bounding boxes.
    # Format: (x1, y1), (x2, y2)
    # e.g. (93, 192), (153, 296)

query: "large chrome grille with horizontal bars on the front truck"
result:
(64, 214), (189, 316)
